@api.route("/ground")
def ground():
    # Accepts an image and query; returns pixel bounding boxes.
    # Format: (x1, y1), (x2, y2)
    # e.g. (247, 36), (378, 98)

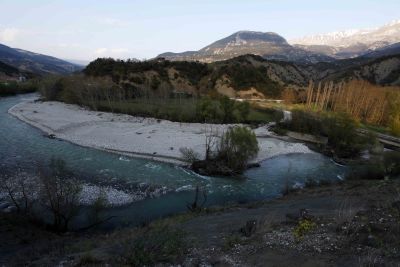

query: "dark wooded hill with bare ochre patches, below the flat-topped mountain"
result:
(84, 55), (318, 98)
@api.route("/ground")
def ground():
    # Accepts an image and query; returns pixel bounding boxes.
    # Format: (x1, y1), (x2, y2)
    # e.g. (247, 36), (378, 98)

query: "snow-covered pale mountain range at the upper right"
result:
(290, 20), (400, 59)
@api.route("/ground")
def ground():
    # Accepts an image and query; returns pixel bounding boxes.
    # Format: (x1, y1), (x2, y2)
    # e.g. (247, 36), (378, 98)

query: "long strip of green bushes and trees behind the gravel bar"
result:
(40, 75), (272, 123)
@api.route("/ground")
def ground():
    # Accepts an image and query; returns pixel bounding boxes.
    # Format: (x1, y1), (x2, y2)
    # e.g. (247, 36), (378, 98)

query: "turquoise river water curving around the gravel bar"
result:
(0, 95), (345, 226)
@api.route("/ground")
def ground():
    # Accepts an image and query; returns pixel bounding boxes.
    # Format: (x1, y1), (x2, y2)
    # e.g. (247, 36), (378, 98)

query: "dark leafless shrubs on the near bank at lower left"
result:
(0, 159), (111, 233)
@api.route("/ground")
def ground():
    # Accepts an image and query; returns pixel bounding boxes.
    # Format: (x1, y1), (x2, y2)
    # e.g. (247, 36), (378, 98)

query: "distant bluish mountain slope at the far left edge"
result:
(0, 44), (82, 75)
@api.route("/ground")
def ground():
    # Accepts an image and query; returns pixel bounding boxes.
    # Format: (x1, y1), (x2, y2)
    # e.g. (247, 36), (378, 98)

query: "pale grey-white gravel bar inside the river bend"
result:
(8, 99), (314, 165)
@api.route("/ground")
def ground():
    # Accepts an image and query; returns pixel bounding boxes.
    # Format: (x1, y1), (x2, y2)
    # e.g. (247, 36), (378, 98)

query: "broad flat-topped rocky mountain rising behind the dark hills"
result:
(157, 31), (333, 63)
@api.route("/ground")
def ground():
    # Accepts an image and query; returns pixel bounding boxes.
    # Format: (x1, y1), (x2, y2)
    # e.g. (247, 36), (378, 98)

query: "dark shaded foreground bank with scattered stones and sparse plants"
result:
(0, 179), (400, 266)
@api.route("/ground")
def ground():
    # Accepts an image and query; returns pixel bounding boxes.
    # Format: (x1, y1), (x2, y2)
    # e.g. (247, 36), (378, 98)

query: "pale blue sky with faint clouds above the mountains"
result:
(0, 0), (400, 60)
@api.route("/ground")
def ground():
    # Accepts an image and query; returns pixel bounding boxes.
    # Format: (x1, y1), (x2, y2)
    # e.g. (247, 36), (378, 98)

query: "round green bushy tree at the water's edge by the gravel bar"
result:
(217, 126), (259, 173)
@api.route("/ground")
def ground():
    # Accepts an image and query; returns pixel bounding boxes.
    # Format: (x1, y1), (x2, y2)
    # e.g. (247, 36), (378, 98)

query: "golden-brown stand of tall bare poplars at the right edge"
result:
(305, 80), (400, 135)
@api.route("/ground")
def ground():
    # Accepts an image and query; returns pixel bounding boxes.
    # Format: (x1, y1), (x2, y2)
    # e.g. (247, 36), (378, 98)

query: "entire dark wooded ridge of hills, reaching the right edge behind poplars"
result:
(84, 51), (400, 101)
